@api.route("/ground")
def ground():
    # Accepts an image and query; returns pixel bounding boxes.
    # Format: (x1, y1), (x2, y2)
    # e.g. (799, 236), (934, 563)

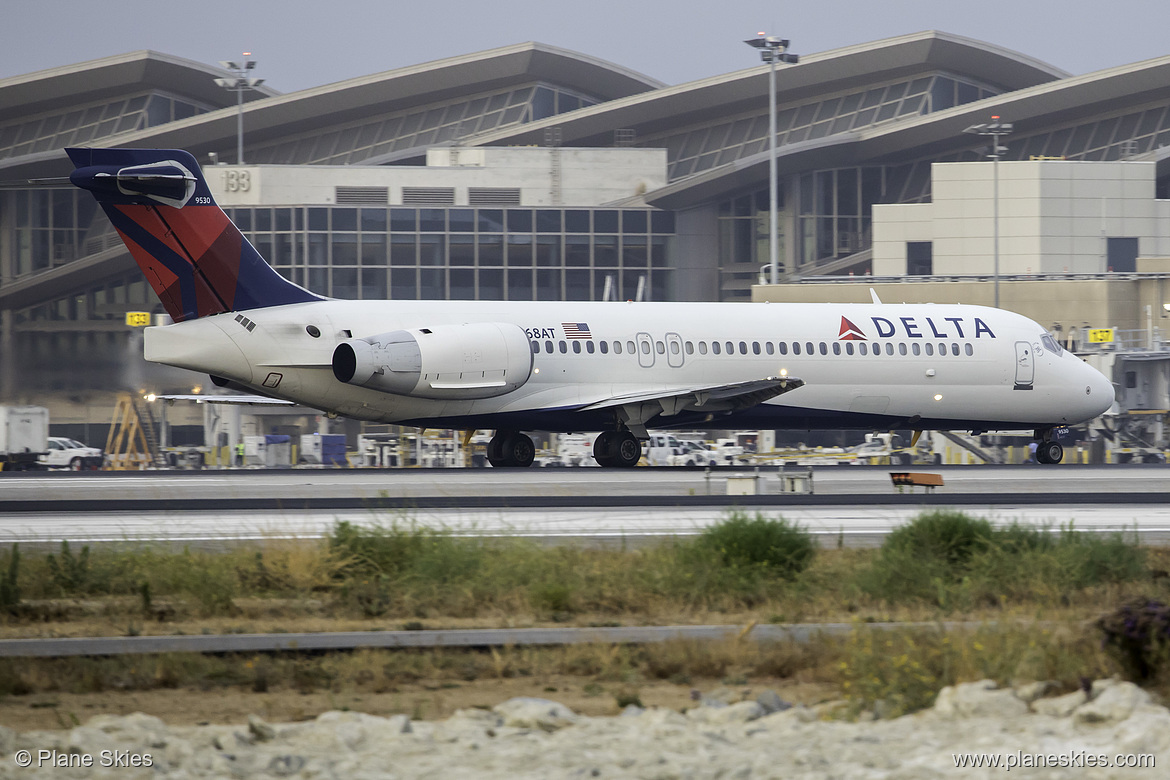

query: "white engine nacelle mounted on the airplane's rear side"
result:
(333, 323), (532, 400)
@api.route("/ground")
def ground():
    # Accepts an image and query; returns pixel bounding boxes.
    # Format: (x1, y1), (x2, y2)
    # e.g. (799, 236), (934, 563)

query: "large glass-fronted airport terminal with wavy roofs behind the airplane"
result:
(0, 32), (1170, 432)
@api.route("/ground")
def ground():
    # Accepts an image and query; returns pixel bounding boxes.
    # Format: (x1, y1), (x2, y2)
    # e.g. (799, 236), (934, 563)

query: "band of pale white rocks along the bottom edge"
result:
(0, 682), (1170, 780)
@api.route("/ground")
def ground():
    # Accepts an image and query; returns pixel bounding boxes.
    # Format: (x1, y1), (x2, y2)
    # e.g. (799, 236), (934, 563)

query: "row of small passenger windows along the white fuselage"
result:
(532, 339), (973, 357)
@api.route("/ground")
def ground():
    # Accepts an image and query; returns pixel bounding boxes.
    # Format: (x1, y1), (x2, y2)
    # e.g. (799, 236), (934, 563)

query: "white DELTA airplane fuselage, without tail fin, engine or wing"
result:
(146, 301), (1114, 432)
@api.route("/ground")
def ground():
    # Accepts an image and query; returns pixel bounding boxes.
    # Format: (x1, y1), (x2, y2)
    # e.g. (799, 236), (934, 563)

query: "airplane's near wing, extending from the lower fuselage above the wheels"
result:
(578, 377), (804, 437)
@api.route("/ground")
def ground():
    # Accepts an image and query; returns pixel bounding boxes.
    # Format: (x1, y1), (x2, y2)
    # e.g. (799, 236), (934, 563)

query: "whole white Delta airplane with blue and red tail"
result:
(67, 149), (1114, 467)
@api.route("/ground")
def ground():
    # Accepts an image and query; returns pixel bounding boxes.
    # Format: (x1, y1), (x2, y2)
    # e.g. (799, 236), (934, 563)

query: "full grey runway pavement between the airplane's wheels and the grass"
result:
(0, 465), (1170, 546)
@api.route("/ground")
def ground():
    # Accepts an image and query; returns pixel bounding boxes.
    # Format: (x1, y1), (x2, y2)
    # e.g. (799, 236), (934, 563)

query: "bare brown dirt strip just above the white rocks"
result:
(0, 675), (834, 731)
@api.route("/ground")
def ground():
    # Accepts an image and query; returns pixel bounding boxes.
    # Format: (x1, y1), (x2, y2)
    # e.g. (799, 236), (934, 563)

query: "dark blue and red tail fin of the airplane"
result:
(66, 149), (323, 322)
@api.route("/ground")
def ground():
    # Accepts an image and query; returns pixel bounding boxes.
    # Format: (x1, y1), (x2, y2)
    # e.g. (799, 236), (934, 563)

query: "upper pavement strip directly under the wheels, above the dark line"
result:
(0, 464), (1170, 500)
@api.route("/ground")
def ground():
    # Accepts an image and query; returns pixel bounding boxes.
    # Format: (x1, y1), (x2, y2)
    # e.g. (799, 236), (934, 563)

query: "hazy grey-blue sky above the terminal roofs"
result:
(0, 0), (1170, 92)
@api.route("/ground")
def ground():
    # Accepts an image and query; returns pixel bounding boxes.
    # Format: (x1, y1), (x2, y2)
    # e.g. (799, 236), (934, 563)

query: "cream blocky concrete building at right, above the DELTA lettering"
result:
(873, 159), (1170, 276)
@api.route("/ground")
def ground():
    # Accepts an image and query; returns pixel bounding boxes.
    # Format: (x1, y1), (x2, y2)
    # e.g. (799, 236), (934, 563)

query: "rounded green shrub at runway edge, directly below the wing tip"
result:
(698, 512), (817, 579)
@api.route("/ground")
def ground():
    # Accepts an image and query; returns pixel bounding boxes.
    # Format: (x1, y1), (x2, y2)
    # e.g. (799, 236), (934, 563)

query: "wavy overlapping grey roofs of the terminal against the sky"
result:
(0, 30), (1170, 195)
